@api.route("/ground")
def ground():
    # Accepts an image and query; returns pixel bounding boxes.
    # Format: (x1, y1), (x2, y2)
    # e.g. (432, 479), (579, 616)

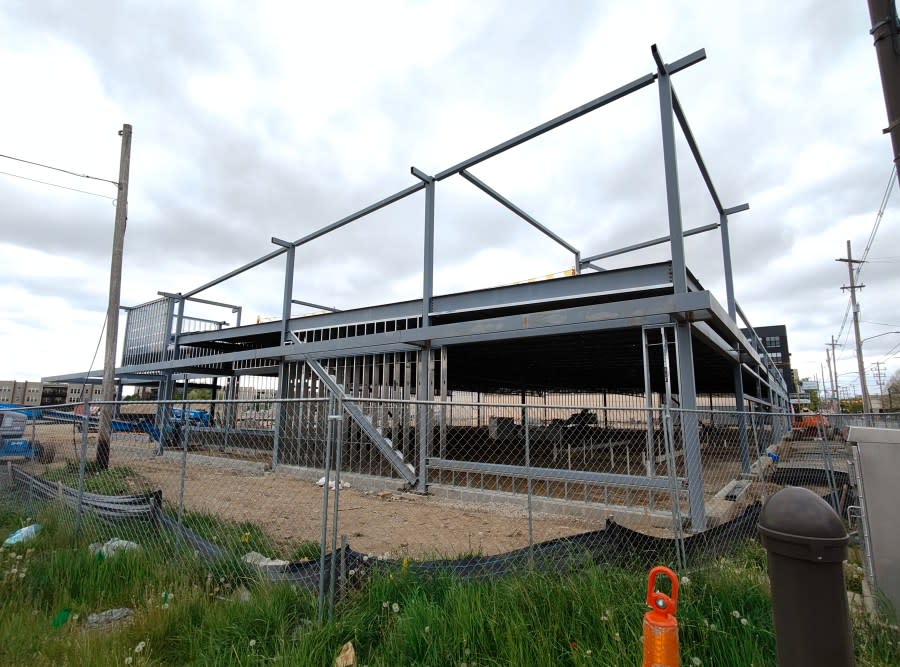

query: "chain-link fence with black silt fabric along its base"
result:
(3, 396), (896, 613)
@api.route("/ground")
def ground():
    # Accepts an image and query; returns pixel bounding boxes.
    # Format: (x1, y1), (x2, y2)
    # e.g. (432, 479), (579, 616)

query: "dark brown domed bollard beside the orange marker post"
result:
(758, 486), (856, 667)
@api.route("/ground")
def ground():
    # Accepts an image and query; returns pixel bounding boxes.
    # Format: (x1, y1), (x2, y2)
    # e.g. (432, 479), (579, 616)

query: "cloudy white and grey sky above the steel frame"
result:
(0, 0), (900, 402)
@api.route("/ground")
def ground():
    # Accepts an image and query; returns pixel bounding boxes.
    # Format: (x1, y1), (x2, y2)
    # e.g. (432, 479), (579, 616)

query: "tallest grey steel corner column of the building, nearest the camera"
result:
(652, 46), (706, 530)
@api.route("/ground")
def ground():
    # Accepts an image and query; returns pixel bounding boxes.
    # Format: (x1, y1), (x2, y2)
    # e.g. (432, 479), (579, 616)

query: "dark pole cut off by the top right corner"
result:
(868, 0), (900, 184)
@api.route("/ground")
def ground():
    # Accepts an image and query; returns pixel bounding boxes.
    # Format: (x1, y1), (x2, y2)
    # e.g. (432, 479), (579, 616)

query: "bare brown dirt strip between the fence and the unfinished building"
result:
(22, 424), (602, 557)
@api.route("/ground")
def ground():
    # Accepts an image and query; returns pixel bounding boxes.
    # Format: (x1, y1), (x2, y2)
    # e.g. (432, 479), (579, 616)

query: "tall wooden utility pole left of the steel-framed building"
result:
(97, 124), (131, 470)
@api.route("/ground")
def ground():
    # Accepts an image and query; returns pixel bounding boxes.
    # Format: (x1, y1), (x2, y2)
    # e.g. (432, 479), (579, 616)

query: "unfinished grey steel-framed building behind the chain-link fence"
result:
(31, 47), (790, 544)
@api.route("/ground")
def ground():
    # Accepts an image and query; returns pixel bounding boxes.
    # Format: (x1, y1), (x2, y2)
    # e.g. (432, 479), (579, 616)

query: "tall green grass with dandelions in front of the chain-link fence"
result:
(0, 504), (900, 667)
